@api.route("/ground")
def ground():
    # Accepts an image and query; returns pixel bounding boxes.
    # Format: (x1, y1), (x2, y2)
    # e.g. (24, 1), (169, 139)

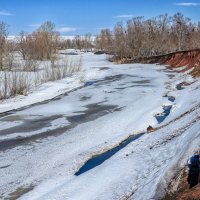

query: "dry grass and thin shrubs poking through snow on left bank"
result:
(0, 54), (82, 100)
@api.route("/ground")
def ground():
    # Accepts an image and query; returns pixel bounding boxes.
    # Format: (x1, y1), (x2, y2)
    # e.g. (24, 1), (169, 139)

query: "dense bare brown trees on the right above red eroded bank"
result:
(95, 13), (200, 59)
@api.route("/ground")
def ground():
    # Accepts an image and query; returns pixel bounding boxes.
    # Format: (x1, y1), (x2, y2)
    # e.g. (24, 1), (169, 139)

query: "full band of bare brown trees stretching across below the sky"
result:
(0, 13), (200, 70)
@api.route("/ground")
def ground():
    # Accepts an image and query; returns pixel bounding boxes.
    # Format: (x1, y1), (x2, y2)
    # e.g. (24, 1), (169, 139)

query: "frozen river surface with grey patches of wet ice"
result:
(0, 54), (198, 199)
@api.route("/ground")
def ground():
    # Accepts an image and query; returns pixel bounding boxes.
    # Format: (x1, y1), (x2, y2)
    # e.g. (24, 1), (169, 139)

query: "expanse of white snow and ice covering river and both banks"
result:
(0, 53), (200, 200)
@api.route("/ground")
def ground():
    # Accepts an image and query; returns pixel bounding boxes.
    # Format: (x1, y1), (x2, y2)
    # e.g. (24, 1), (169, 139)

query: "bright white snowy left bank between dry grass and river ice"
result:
(0, 51), (104, 113)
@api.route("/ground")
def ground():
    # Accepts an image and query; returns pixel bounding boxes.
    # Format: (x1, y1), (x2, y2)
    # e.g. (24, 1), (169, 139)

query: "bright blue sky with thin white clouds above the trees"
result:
(0, 0), (200, 35)
